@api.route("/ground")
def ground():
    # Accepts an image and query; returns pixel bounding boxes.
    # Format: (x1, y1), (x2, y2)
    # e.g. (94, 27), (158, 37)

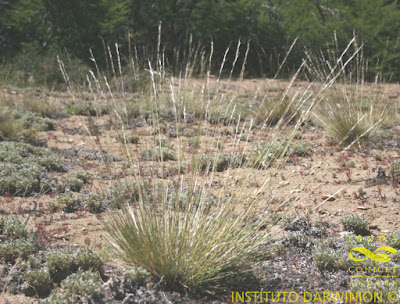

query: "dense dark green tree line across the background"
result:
(0, 0), (400, 81)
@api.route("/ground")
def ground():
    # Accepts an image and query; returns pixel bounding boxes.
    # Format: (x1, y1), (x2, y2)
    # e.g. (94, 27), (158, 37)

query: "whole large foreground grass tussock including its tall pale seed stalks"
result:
(58, 33), (357, 290)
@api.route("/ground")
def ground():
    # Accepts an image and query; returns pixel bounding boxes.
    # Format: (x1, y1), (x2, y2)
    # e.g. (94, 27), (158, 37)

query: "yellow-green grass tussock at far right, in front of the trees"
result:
(307, 36), (395, 148)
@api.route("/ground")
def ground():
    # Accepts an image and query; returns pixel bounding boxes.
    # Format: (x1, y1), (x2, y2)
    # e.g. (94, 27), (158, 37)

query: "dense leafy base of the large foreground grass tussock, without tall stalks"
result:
(107, 180), (267, 290)
